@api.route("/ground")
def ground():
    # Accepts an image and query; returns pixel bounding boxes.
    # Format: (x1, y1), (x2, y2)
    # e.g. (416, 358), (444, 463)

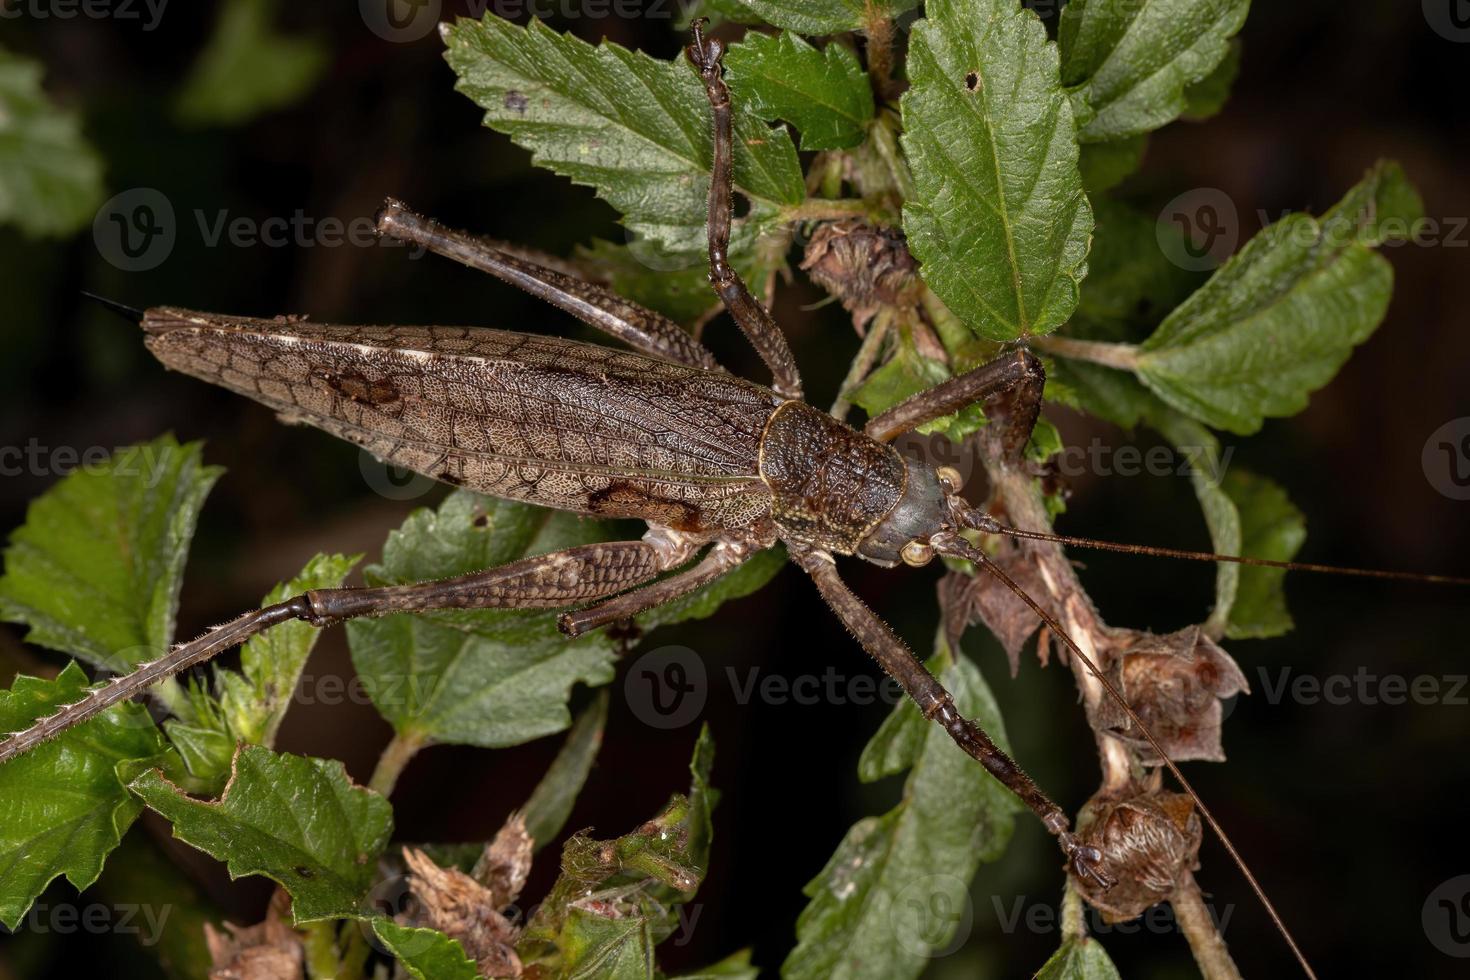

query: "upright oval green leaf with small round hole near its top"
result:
(903, 0), (1092, 341)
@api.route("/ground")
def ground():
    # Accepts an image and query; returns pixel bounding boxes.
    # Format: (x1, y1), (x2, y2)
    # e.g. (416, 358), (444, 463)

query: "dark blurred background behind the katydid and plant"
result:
(0, 0), (1470, 977)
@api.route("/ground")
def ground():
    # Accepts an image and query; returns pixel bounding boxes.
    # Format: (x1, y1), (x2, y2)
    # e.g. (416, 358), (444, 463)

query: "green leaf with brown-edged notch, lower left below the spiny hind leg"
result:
(129, 745), (392, 926)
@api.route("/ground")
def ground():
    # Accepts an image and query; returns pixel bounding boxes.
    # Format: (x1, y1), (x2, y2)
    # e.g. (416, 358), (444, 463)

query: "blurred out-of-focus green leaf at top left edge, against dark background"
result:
(175, 0), (331, 126)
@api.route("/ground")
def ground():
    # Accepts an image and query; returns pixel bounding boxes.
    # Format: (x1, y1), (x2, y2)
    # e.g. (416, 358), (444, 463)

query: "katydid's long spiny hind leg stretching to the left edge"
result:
(0, 532), (692, 763)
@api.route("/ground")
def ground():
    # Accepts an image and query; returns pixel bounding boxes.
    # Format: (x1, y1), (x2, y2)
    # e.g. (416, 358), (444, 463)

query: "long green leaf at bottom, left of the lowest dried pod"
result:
(781, 638), (1019, 980)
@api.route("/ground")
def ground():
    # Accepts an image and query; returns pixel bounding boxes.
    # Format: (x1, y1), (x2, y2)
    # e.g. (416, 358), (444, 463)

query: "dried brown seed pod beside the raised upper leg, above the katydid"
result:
(801, 219), (919, 331)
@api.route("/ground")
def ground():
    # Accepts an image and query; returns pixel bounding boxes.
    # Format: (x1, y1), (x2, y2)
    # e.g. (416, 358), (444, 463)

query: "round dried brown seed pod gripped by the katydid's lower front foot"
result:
(1073, 790), (1201, 923)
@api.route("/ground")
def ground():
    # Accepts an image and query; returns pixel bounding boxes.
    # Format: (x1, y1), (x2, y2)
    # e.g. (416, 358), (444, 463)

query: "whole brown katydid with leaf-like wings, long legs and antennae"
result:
(0, 26), (1464, 974)
